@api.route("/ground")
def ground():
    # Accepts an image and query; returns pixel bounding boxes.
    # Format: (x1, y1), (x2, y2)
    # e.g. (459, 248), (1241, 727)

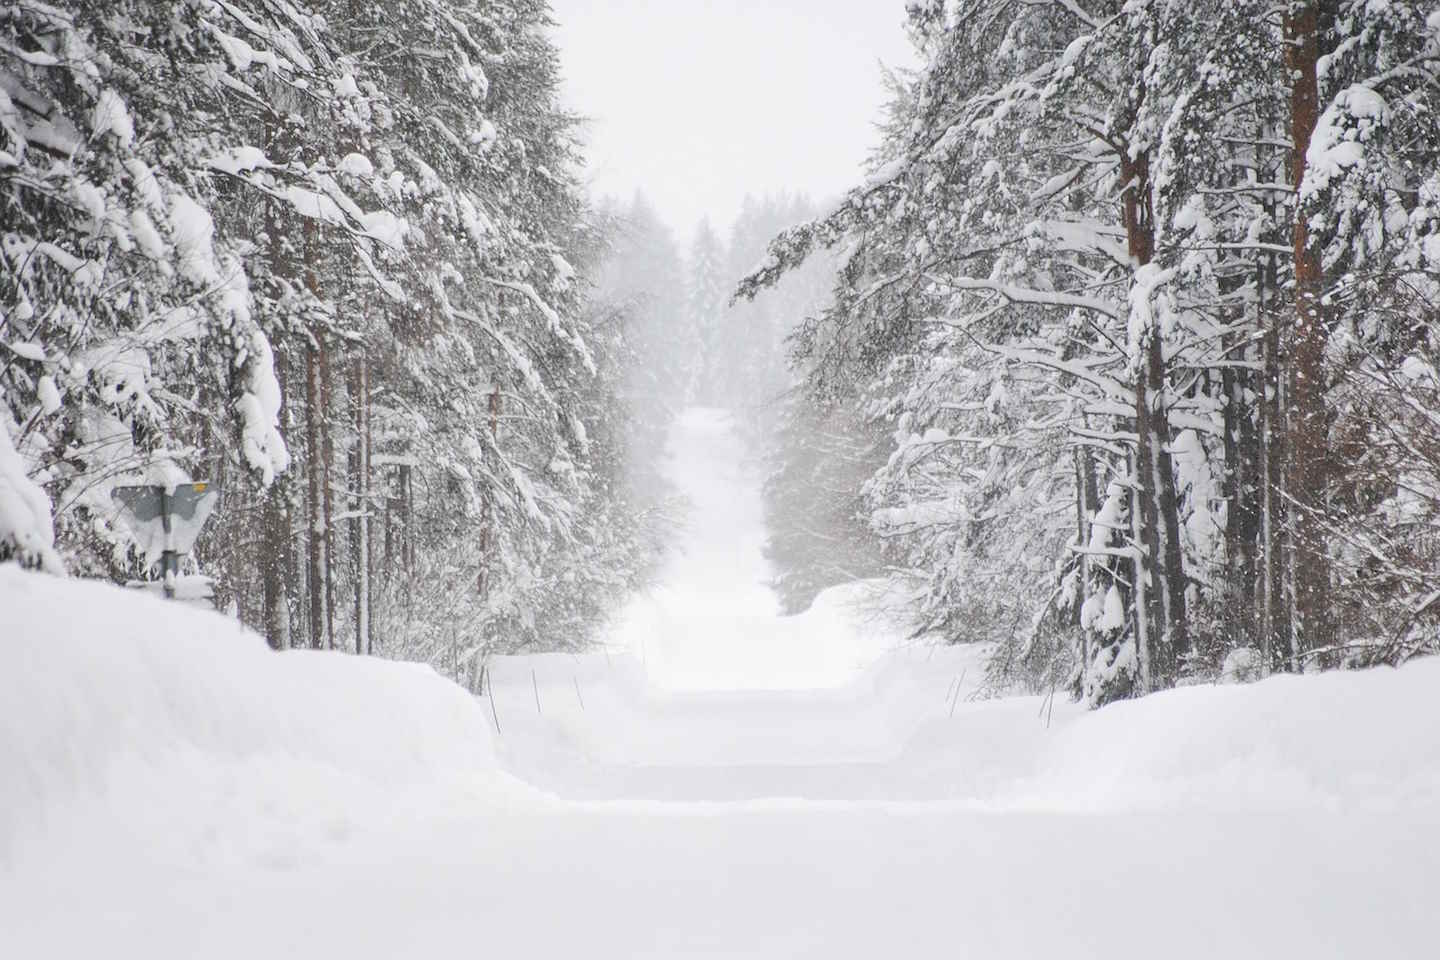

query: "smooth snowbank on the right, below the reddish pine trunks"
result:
(1001, 658), (1440, 813)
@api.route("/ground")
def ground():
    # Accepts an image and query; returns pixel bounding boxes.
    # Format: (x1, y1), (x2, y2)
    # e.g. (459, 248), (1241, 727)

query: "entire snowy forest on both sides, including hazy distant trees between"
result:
(0, 0), (1440, 705)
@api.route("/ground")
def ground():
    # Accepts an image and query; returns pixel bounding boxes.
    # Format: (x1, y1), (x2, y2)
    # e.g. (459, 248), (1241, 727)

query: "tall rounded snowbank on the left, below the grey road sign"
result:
(0, 564), (510, 864)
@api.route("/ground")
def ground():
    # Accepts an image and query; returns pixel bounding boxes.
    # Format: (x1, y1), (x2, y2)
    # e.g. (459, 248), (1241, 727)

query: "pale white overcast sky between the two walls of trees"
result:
(552, 0), (913, 243)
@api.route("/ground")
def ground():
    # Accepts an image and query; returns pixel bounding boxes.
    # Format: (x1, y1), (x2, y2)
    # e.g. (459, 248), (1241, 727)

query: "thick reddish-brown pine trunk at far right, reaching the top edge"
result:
(1284, 0), (1333, 658)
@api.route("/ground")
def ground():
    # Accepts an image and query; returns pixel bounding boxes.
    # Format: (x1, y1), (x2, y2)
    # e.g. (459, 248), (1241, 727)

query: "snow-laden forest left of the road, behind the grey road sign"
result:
(0, 0), (670, 676)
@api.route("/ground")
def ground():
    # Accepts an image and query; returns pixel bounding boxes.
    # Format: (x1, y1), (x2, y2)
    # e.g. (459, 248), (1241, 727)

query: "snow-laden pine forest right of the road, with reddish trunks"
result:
(740, 0), (1440, 705)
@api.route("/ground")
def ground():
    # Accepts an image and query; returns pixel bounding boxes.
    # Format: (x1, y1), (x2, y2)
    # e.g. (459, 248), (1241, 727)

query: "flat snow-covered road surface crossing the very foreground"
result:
(19, 803), (1436, 960)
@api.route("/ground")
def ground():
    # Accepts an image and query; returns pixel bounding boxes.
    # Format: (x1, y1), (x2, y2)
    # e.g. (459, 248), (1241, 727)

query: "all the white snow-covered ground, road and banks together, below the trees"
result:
(0, 412), (1440, 960)
